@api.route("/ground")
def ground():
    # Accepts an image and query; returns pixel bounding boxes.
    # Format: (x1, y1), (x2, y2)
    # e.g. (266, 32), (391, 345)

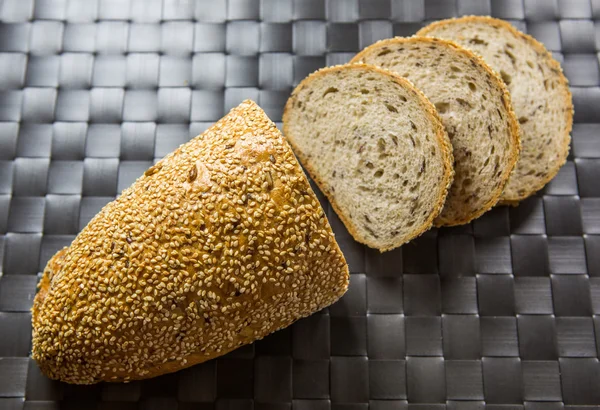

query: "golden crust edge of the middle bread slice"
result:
(350, 36), (521, 227)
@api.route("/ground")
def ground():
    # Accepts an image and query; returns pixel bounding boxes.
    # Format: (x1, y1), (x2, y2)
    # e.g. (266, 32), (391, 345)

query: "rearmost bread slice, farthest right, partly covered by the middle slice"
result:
(417, 16), (573, 204)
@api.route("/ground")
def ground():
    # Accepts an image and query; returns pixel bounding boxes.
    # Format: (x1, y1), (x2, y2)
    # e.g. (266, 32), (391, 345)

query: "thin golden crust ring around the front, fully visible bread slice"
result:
(283, 63), (454, 252)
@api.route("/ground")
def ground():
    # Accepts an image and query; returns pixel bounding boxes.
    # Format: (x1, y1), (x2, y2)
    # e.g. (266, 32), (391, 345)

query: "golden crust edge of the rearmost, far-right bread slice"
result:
(416, 16), (574, 206)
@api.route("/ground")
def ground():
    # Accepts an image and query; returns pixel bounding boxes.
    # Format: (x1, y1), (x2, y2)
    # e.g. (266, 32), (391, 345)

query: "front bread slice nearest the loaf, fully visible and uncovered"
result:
(283, 64), (453, 251)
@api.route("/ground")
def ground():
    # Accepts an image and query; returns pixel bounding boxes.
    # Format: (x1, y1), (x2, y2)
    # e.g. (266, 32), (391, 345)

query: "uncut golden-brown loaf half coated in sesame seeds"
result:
(32, 101), (349, 384)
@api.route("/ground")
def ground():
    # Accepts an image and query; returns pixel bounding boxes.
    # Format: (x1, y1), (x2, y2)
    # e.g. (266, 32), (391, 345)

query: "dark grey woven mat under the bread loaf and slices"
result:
(0, 0), (600, 410)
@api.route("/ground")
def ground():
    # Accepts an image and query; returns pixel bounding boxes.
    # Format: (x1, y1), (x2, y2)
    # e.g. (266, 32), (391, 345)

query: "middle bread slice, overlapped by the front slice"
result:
(351, 37), (519, 226)
